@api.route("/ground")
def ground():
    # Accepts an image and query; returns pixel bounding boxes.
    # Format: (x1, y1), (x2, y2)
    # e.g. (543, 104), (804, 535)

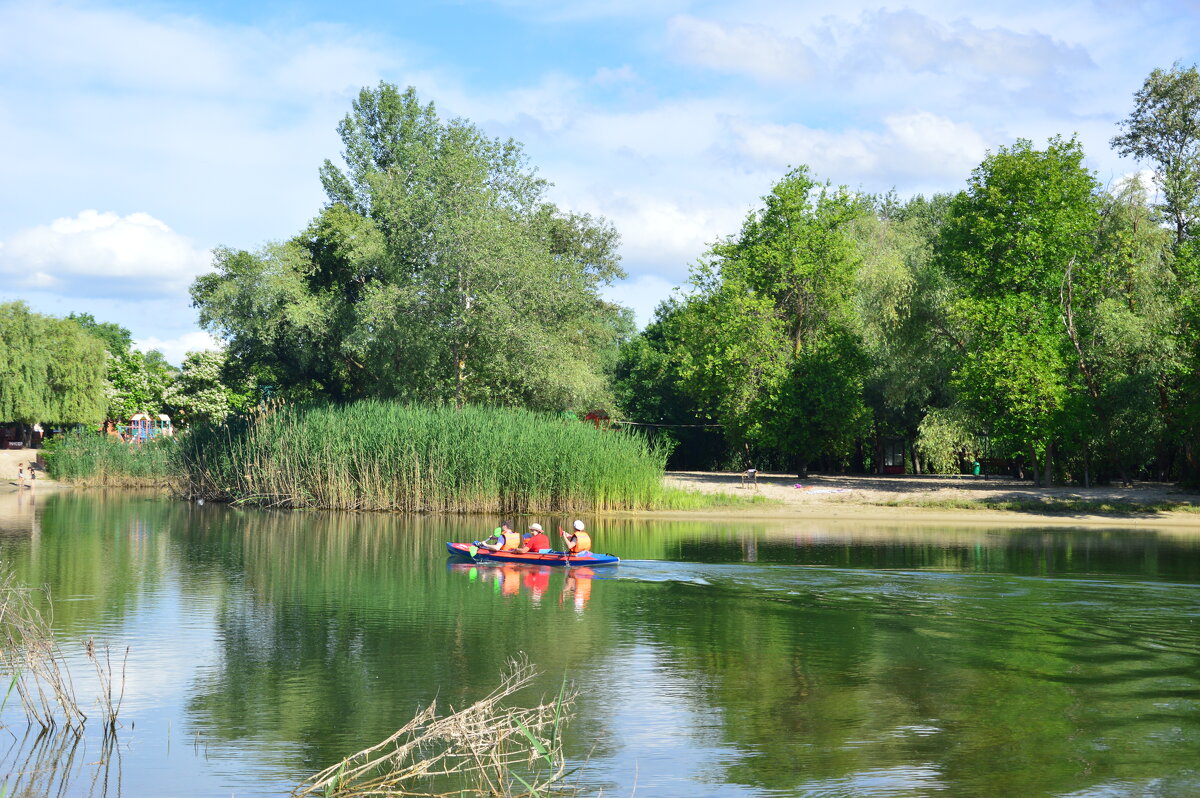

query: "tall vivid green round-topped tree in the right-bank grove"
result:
(937, 138), (1099, 479)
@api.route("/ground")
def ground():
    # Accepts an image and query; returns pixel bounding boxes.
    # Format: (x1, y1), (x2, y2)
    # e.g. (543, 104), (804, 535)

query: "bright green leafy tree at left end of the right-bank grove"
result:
(657, 167), (866, 468)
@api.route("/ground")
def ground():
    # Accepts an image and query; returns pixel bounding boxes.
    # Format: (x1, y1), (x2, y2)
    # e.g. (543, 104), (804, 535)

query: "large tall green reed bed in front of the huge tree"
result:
(181, 401), (666, 512)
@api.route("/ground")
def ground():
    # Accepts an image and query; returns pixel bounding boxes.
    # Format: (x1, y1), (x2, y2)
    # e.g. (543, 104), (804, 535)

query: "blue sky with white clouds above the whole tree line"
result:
(0, 0), (1200, 362)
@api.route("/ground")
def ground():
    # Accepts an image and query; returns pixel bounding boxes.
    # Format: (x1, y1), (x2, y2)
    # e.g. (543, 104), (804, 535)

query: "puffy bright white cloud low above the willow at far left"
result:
(0, 210), (211, 296)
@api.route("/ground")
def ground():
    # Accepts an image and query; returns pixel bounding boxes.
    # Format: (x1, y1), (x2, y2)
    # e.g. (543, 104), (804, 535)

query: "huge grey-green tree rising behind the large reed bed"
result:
(192, 84), (629, 409)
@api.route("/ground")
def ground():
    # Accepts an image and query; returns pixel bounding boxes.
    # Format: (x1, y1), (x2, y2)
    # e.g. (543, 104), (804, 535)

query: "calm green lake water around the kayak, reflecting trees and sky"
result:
(0, 492), (1200, 798)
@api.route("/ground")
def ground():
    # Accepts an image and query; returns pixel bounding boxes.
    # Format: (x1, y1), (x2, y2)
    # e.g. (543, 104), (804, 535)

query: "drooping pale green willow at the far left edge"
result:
(0, 302), (107, 442)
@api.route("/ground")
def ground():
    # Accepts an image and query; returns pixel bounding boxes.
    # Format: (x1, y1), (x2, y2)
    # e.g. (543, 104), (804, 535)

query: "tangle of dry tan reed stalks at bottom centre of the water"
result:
(293, 659), (576, 798)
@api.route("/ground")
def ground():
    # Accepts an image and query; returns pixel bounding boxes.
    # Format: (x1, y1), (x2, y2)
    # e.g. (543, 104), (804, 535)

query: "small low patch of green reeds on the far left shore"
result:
(42, 432), (178, 487)
